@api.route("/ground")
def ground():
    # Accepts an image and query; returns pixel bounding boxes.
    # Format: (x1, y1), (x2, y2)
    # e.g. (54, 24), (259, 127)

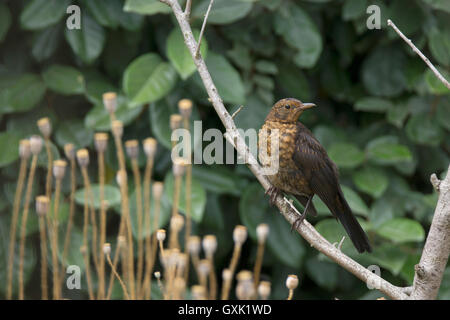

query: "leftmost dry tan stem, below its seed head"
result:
(6, 158), (28, 300)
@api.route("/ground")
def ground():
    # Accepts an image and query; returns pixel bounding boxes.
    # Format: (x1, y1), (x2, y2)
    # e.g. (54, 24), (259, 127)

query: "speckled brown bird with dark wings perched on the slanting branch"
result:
(258, 98), (372, 253)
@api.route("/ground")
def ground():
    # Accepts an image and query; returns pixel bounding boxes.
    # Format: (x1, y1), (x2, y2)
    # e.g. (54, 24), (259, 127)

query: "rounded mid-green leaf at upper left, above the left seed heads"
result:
(42, 64), (84, 95)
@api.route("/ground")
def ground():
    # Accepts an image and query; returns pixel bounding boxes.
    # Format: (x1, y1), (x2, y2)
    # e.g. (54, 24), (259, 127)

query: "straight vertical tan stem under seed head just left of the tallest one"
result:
(98, 152), (106, 300)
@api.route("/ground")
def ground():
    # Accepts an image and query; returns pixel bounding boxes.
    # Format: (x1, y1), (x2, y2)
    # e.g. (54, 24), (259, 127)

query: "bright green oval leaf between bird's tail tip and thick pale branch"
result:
(376, 218), (425, 243)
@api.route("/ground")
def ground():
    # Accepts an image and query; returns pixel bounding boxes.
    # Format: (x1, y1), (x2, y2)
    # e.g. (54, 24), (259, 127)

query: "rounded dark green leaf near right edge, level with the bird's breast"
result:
(406, 114), (444, 146)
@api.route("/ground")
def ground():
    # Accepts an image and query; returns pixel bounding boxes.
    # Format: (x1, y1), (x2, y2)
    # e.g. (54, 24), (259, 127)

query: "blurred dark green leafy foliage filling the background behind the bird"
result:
(0, 0), (450, 299)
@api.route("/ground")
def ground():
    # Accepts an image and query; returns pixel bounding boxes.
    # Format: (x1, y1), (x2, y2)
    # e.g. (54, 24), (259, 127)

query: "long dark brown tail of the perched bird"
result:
(332, 190), (372, 253)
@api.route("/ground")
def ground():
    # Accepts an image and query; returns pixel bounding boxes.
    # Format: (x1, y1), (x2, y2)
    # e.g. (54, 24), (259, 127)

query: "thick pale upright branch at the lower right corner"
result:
(410, 166), (450, 299)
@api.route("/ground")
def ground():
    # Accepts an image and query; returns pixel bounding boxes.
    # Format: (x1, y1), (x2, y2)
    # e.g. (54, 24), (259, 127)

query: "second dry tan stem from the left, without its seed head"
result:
(19, 155), (37, 300)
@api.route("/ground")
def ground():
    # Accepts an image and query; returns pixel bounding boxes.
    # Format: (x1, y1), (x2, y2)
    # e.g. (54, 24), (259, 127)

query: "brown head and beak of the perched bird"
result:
(266, 98), (316, 122)
